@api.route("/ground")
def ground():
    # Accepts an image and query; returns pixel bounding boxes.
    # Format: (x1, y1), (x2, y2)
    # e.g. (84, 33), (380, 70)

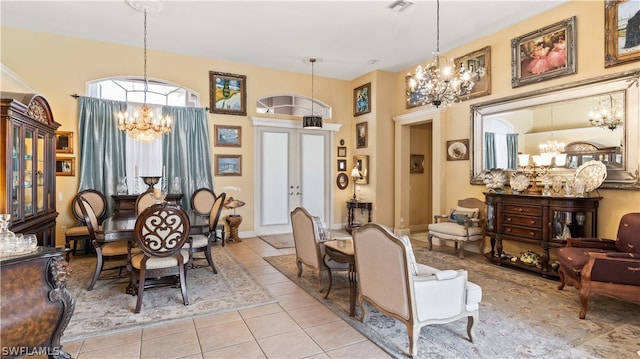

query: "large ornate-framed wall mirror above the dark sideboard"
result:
(470, 71), (640, 190)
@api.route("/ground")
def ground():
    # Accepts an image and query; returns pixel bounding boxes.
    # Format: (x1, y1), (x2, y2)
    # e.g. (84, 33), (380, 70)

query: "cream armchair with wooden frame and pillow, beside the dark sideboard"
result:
(428, 197), (485, 258)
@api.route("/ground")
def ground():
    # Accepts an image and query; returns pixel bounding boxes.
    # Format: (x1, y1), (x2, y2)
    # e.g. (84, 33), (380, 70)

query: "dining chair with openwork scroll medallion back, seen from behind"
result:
(129, 203), (190, 313)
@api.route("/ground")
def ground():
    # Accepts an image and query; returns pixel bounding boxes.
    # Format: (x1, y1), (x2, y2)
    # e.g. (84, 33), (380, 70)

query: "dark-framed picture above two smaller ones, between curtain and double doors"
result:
(209, 71), (247, 116)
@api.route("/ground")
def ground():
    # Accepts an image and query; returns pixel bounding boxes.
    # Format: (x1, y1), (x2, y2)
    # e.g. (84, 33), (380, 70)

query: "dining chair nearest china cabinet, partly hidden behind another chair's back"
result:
(64, 189), (107, 262)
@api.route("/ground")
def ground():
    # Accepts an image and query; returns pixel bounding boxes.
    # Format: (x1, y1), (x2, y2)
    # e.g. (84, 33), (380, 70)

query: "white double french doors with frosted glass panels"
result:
(254, 121), (332, 235)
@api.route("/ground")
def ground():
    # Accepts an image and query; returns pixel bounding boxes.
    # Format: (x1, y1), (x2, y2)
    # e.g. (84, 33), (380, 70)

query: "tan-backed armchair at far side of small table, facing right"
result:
(291, 207), (349, 291)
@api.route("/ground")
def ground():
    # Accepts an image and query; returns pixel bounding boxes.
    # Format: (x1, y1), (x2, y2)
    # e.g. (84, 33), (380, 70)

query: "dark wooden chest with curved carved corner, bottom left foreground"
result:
(0, 247), (75, 358)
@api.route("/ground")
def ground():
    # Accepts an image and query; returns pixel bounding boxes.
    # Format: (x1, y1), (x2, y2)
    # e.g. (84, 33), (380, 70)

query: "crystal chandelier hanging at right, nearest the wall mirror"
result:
(407, 0), (473, 108)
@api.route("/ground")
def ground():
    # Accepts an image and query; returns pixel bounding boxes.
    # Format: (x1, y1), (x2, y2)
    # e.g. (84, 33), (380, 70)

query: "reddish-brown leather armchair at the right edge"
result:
(558, 213), (640, 319)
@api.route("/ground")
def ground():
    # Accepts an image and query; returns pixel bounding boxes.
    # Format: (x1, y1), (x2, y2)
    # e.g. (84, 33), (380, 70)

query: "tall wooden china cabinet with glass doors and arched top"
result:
(0, 92), (60, 247)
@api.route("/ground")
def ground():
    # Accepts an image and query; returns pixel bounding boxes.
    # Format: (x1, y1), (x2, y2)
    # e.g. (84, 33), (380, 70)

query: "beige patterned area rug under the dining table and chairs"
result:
(62, 246), (275, 342)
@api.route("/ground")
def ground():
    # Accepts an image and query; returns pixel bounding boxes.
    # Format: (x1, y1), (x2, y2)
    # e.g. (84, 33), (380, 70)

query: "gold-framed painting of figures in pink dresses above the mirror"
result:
(511, 16), (576, 88)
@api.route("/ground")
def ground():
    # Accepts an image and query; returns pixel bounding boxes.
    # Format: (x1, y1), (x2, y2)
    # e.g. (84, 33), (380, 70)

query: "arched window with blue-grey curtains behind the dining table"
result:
(79, 77), (213, 207)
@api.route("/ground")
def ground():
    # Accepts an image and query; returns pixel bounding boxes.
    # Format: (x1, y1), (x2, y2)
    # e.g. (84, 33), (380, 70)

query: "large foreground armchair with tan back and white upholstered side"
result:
(353, 223), (482, 356)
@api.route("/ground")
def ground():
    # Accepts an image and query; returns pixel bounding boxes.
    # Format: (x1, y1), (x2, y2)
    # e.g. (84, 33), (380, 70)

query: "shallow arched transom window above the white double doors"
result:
(256, 95), (331, 119)
